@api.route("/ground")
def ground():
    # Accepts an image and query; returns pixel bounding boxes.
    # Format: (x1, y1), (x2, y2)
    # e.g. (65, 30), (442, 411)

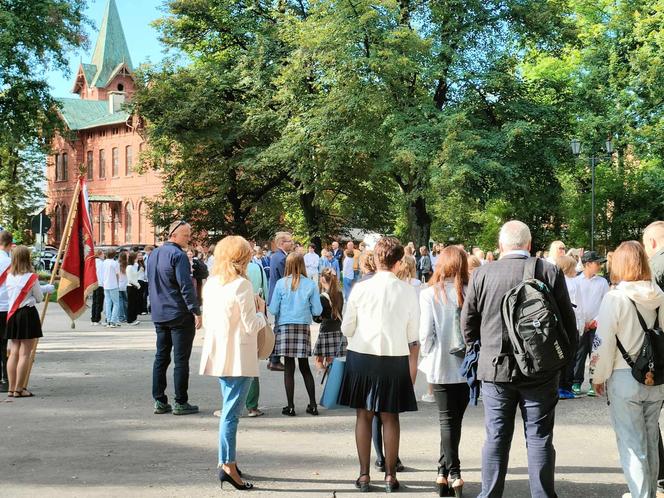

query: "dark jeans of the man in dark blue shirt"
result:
(152, 314), (196, 404)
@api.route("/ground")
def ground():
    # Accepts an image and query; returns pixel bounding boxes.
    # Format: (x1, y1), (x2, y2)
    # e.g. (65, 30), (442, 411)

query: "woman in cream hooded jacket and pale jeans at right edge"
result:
(590, 241), (664, 498)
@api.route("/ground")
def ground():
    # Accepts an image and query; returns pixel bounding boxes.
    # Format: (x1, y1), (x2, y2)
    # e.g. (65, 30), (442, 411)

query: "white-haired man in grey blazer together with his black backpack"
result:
(461, 220), (578, 498)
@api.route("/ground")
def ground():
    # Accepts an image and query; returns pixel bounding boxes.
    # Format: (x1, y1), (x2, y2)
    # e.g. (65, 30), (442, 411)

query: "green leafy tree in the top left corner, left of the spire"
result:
(0, 0), (86, 233)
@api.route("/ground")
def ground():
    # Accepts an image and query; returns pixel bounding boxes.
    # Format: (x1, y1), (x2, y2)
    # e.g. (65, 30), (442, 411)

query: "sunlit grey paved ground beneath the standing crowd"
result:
(0, 305), (644, 498)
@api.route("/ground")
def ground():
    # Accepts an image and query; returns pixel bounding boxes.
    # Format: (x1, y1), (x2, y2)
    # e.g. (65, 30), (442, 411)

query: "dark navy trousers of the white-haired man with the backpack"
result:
(478, 374), (558, 498)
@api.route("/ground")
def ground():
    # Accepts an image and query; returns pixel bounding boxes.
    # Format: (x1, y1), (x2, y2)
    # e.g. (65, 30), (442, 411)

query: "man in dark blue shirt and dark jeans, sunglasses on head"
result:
(146, 221), (202, 415)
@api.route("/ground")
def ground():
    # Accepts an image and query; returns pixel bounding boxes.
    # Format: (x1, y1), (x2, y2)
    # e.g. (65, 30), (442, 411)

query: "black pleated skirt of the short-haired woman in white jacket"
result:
(338, 350), (417, 413)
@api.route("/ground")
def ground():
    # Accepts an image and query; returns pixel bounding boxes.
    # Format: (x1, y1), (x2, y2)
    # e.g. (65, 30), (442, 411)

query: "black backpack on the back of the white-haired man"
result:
(501, 258), (571, 378)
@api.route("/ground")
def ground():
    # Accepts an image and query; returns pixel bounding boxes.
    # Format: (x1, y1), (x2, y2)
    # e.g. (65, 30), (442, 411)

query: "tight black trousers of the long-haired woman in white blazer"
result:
(432, 382), (470, 479)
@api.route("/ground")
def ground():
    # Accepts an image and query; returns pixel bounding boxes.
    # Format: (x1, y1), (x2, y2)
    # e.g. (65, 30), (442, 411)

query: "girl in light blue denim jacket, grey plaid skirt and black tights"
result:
(268, 252), (323, 417)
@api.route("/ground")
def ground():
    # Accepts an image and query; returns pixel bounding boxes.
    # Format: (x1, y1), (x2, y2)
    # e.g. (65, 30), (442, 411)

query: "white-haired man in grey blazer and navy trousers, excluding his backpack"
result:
(461, 221), (578, 498)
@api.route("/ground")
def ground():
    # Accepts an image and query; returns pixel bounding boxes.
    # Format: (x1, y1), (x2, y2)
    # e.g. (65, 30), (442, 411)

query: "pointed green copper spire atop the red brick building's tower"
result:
(90, 0), (132, 88)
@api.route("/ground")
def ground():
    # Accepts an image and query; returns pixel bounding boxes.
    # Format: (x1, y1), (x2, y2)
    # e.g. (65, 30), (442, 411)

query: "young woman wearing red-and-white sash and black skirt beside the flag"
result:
(5, 246), (55, 398)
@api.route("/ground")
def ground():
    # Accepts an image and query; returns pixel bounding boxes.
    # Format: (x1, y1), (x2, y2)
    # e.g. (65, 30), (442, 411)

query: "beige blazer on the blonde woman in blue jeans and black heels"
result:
(200, 275), (266, 377)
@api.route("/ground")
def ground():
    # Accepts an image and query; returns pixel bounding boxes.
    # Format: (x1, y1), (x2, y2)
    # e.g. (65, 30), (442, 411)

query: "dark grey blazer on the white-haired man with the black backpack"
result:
(461, 254), (578, 383)
